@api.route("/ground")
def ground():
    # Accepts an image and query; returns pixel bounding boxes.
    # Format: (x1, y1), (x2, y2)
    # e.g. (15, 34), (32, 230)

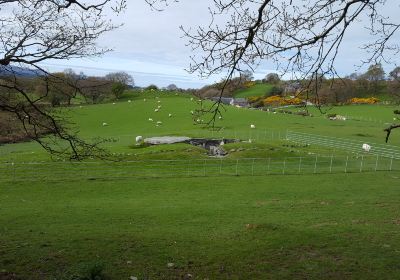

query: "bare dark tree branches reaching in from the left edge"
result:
(0, 0), (126, 159)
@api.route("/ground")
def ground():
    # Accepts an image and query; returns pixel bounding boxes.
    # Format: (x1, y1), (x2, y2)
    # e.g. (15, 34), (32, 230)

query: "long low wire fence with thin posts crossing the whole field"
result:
(0, 155), (400, 182)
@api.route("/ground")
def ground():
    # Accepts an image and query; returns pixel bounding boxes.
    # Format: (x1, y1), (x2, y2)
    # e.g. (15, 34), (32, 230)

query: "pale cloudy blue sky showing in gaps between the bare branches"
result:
(38, 0), (400, 88)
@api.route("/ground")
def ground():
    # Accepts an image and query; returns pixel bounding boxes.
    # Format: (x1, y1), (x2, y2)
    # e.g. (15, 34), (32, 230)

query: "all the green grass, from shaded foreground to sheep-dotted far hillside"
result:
(0, 92), (400, 280)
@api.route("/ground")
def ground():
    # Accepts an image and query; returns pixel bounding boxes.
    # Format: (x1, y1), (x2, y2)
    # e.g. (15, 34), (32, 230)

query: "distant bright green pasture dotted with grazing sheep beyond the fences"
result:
(0, 92), (400, 161)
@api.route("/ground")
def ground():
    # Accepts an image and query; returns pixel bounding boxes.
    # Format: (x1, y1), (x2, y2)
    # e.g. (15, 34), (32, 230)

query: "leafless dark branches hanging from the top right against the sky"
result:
(182, 0), (400, 138)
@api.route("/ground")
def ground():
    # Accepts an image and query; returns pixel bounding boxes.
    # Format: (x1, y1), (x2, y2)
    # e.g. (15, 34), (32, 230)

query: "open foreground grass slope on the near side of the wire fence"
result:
(0, 172), (400, 280)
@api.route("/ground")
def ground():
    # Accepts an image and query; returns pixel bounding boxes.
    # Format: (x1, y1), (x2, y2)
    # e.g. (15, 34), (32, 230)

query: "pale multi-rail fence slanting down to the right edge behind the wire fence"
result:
(286, 131), (400, 159)
